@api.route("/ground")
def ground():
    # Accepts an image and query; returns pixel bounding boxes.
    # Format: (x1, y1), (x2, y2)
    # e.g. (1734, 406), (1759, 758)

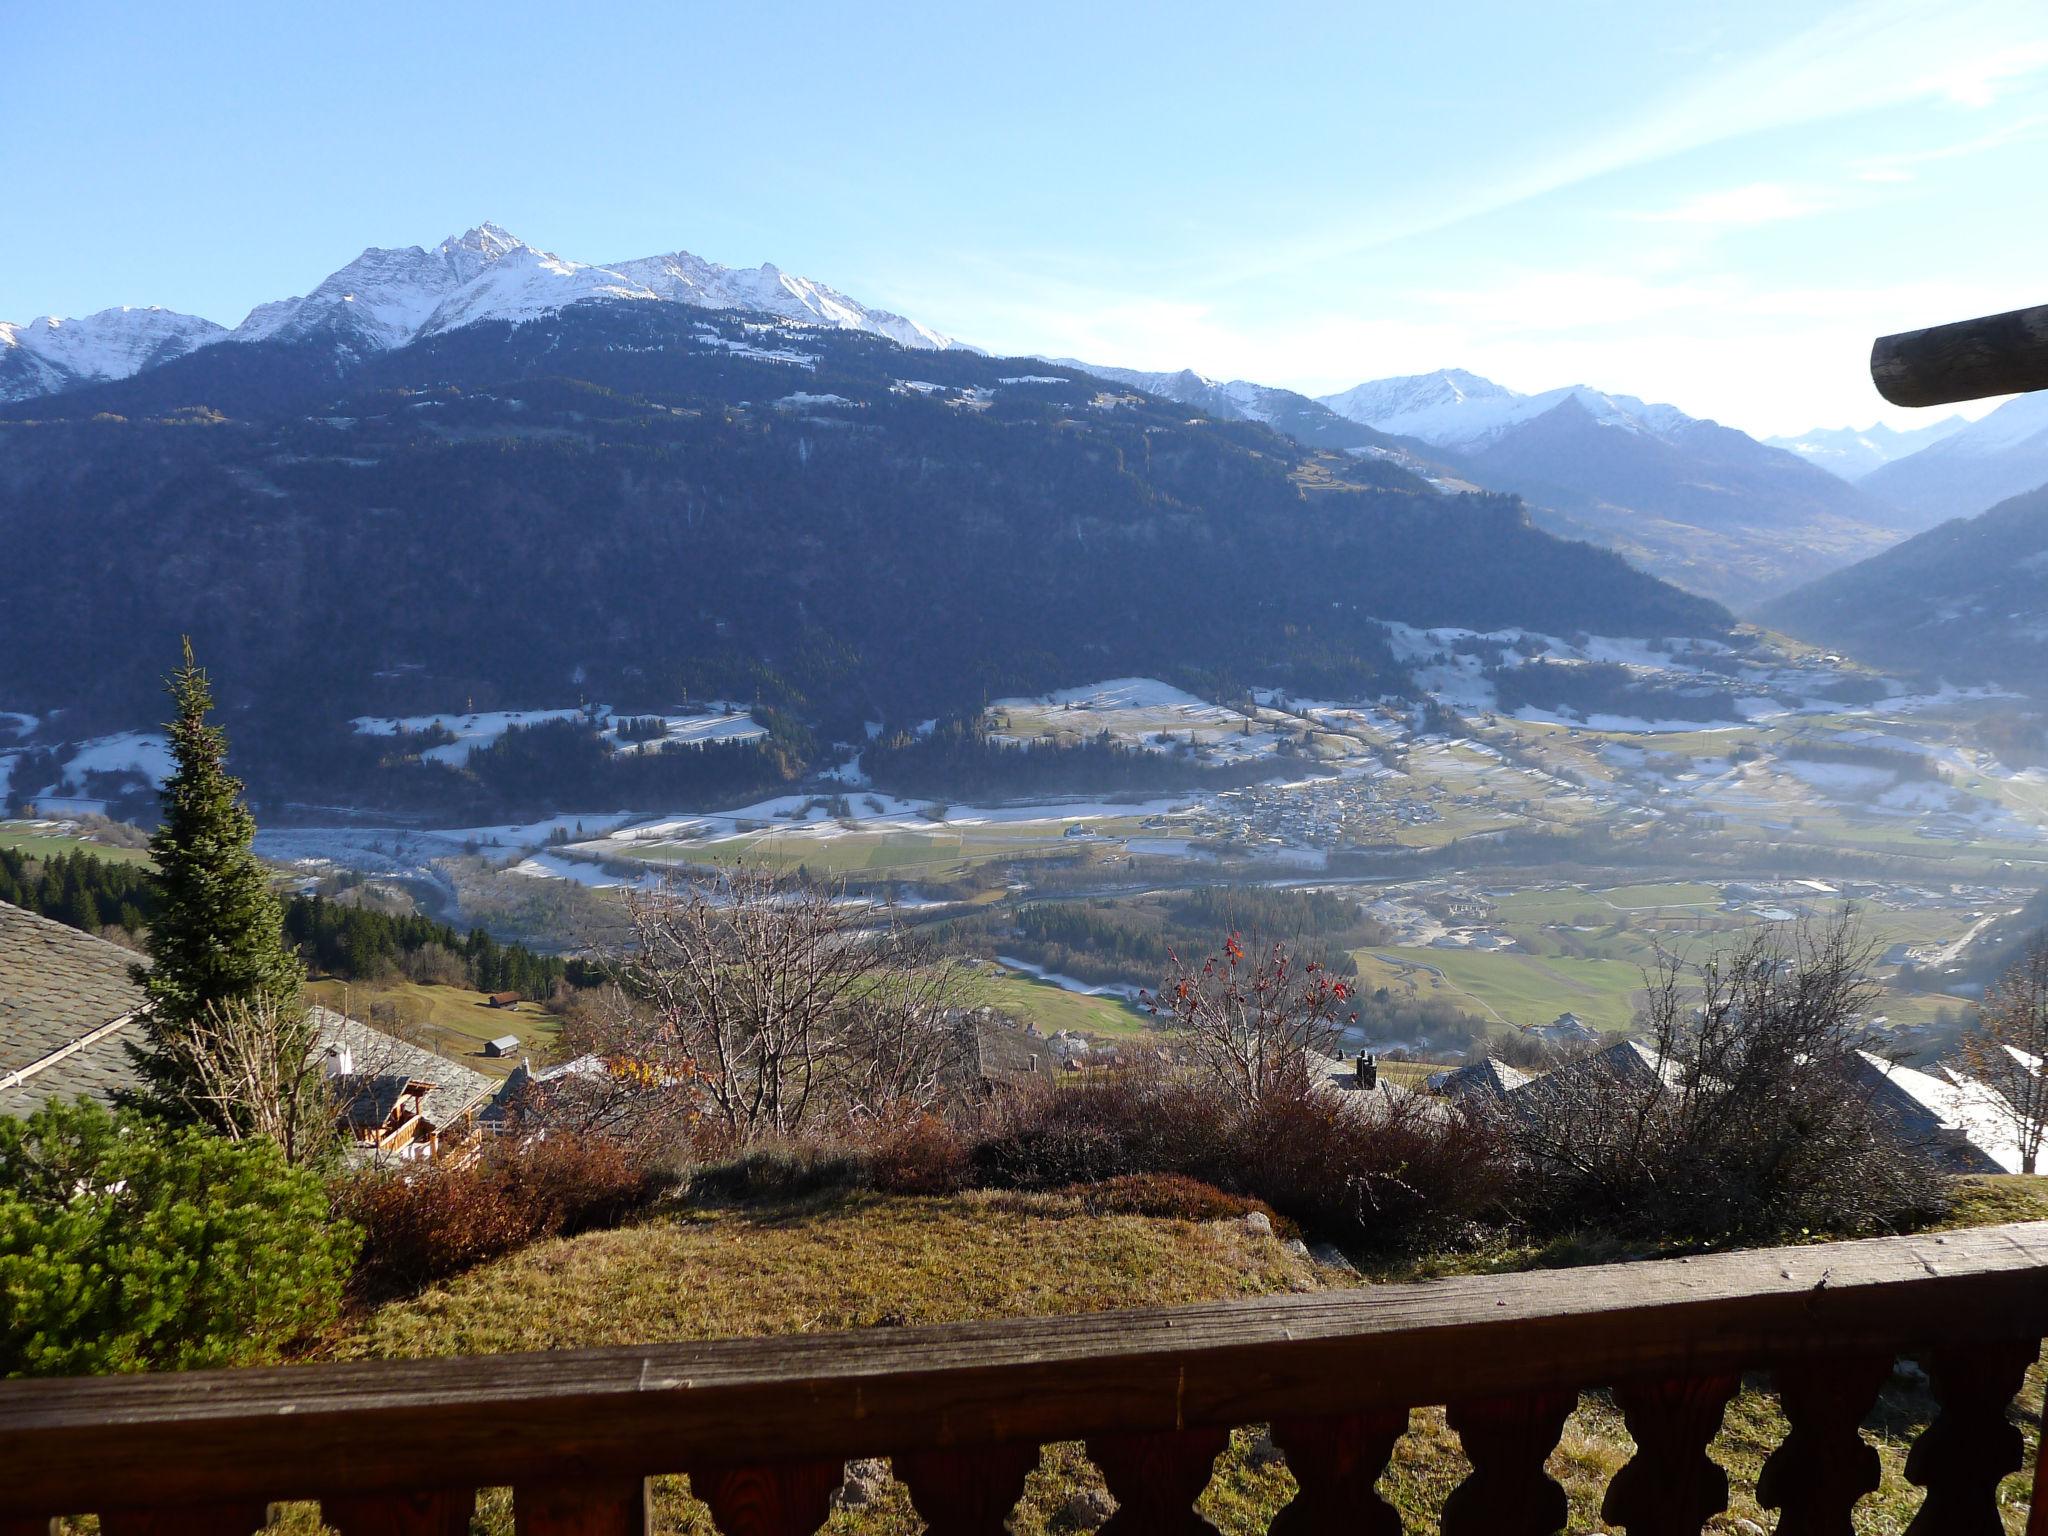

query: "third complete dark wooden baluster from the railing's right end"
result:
(1599, 1376), (1741, 1536)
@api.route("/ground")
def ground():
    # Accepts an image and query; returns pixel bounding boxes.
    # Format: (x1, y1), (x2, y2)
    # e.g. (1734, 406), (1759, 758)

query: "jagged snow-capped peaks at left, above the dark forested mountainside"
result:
(0, 223), (963, 401)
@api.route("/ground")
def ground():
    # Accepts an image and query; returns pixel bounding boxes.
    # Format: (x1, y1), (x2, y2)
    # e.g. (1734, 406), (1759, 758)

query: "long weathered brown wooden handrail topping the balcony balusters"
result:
(0, 1223), (2048, 1528)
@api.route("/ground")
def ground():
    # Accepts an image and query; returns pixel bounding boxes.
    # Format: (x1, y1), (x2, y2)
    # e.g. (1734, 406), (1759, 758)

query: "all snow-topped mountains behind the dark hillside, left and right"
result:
(0, 223), (2048, 608)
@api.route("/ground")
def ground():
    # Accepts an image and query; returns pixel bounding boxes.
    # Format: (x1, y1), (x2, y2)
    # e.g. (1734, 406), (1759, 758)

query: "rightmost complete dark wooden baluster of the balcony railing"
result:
(1907, 1339), (2040, 1536)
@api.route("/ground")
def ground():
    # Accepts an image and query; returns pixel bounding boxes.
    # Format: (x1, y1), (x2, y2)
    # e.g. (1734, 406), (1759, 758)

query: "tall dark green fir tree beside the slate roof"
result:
(129, 639), (305, 1120)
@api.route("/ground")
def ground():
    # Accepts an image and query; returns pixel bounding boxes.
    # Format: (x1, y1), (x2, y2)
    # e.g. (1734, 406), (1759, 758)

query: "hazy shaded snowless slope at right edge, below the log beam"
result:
(1759, 481), (2048, 702)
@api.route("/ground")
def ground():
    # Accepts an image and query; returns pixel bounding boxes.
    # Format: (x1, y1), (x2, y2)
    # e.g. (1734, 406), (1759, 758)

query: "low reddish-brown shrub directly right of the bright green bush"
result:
(336, 1137), (653, 1300)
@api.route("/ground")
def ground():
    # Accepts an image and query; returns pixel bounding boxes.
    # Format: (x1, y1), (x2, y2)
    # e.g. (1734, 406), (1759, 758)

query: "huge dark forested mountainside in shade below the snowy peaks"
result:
(0, 303), (1726, 793)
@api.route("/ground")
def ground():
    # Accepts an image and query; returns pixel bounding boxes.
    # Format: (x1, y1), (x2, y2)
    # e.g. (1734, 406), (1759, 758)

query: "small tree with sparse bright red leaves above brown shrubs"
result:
(1141, 934), (1356, 1110)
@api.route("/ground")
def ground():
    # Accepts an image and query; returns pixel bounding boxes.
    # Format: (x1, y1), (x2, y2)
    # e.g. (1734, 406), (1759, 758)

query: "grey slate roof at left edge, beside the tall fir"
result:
(0, 901), (143, 1114)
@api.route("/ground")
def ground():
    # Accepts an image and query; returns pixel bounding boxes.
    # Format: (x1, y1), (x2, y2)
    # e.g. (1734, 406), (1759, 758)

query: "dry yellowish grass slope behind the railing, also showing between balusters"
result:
(338, 1178), (2048, 1536)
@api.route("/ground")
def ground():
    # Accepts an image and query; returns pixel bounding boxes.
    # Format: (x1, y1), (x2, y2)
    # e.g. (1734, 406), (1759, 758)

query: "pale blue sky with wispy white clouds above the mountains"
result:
(0, 0), (2048, 436)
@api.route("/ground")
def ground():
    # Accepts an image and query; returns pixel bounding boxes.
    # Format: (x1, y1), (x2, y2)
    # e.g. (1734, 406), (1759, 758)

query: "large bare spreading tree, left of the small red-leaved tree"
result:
(590, 868), (963, 1147)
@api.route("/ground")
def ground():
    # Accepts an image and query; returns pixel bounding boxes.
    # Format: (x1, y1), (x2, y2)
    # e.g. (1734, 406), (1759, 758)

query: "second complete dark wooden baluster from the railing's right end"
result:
(1757, 1356), (1892, 1536)
